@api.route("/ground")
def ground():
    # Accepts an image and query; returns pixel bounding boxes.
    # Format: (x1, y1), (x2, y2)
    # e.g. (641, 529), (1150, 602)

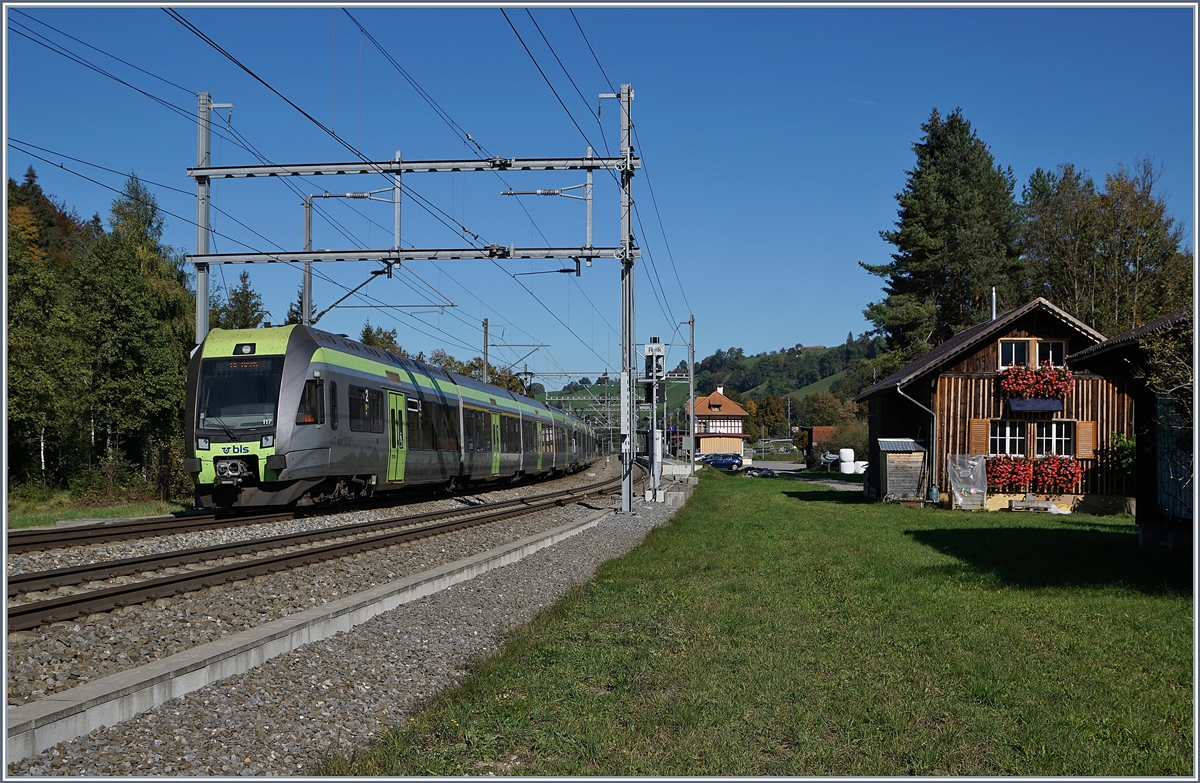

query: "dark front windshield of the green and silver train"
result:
(197, 357), (283, 430)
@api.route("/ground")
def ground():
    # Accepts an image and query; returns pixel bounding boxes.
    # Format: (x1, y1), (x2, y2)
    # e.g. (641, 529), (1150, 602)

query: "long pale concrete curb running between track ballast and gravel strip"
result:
(5, 509), (612, 761)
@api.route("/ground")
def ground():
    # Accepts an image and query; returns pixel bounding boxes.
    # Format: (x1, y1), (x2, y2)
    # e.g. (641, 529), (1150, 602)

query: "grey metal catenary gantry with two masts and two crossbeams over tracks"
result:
(187, 84), (642, 513)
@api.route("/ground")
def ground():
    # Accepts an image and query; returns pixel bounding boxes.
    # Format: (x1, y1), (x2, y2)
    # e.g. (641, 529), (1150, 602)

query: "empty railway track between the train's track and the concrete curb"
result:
(7, 470), (620, 632)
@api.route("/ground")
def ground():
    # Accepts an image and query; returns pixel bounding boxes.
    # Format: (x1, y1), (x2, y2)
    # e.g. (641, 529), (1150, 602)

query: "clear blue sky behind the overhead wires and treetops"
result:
(5, 6), (1195, 384)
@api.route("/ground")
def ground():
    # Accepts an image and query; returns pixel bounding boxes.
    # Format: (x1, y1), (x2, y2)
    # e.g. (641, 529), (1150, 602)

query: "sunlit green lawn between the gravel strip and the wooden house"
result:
(324, 471), (1195, 776)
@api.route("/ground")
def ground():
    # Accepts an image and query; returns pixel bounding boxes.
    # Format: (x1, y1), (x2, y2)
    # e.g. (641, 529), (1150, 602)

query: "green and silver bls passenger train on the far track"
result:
(184, 325), (596, 508)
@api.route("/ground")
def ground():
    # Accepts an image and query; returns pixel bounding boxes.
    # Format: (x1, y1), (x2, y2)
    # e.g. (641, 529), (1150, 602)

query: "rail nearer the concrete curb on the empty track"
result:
(7, 470), (617, 632)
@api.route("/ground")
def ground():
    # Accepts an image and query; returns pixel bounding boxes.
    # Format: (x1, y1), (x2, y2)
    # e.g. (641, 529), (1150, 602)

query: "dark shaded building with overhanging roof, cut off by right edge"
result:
(1067, 310), (1194, 549)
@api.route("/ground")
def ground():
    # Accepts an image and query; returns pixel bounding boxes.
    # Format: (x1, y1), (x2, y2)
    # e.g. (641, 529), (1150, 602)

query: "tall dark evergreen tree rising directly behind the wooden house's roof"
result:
(862, 108), (1024, 365)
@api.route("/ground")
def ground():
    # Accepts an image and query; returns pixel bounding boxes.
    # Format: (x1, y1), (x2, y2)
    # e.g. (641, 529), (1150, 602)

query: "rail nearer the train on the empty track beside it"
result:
(8, 477), (619, 598)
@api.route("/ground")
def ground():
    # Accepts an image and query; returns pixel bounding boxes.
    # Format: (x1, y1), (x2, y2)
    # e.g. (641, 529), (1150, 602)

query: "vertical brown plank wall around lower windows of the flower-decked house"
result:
(931, 373), (1134, 495)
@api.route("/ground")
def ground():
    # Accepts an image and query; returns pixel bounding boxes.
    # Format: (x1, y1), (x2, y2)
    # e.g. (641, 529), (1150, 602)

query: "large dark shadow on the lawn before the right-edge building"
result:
(905, 527), (1192, 594)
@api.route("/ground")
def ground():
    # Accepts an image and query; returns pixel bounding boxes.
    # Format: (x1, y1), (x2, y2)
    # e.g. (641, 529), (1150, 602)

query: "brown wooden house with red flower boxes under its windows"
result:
(857, 298), (1134, 512)
